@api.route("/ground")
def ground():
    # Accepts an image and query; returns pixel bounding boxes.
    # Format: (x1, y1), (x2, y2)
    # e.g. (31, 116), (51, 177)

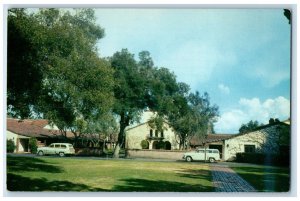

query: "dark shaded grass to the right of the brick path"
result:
(231, 166), (290, 192)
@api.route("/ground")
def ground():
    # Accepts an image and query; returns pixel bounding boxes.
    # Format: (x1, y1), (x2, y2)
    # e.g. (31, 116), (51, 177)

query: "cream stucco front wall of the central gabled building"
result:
(126, 123), (179, 150)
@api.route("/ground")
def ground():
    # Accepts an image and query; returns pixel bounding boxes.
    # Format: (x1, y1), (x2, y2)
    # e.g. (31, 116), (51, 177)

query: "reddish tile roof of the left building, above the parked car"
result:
(6, 118), (73, 137)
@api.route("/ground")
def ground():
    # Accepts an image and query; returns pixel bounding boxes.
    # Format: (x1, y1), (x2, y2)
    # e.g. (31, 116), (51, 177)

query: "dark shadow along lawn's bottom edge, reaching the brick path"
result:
(113, 178), (213, 192)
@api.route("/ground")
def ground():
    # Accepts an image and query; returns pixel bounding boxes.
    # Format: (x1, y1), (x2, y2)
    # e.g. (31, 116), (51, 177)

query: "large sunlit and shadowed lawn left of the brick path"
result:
(7, 156), (214, 192)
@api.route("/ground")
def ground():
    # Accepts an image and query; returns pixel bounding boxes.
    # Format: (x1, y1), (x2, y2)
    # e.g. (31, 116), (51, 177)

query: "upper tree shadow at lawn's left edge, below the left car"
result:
(7, 157), (63, 173)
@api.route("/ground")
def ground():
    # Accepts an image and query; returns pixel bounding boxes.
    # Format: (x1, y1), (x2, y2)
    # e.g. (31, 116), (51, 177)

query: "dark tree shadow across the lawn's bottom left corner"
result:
(7, 173), (105, 192)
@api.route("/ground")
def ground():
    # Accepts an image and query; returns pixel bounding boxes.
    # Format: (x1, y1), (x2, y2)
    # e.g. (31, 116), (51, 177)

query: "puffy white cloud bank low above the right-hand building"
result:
(215, 96), (290, 133)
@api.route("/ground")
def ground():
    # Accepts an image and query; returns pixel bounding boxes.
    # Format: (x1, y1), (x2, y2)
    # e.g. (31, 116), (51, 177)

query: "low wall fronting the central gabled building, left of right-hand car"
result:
(126, 149), (187, 160)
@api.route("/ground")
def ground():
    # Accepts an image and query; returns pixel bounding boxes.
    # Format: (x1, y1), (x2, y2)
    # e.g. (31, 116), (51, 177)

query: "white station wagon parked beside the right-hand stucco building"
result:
(182, 149), (220, 163)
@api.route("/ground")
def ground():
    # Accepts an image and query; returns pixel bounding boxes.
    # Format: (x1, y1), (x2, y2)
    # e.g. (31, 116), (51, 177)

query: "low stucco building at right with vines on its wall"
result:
(191, 121), (291, 161)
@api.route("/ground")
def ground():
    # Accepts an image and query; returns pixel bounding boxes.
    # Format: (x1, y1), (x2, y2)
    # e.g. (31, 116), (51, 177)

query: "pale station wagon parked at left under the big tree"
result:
(36, 143), (75, 157)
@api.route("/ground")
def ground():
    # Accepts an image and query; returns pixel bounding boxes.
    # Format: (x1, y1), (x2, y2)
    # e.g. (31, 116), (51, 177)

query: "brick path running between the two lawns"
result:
(211, 165), (255, 192)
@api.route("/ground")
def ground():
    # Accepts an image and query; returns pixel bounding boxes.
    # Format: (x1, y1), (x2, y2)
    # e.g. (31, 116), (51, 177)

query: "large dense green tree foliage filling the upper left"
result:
(7, 9), (114, 140)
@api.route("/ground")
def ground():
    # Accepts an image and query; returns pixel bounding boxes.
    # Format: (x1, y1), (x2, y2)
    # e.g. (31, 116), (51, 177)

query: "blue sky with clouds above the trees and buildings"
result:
(96, 8), (290, 134)
